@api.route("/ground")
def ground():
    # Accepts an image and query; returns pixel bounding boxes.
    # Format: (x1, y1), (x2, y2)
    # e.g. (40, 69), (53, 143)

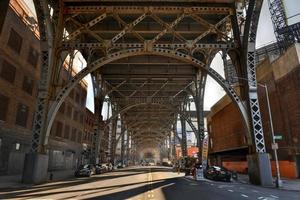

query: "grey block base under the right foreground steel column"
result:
(247, 153), (273, 186)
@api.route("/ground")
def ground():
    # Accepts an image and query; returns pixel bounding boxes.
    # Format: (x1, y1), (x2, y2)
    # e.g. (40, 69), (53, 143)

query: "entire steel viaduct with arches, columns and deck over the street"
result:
(0, 0), (272, 185)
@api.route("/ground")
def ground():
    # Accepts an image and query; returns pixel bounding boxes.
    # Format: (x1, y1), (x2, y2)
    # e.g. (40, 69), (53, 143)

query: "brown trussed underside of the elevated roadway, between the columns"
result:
(62, 0), (236, 146)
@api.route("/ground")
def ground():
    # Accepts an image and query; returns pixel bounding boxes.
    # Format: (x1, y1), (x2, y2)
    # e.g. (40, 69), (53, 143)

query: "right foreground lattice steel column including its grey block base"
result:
(243, 0), (273, 186)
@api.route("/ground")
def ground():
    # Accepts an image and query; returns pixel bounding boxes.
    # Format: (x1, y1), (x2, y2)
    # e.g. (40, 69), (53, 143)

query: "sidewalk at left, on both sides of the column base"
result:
(0, 170), (74, 189)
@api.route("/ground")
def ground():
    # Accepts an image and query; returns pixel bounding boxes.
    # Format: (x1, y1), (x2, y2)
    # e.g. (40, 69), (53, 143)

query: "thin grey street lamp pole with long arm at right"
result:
(234, 77), (282, 188)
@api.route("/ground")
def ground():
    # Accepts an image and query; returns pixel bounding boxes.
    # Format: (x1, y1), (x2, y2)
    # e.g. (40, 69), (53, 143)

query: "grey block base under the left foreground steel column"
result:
(22, 153), (49, 184)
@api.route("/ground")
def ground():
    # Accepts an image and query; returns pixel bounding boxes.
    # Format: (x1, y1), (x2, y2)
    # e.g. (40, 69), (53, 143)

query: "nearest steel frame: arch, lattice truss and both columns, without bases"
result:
(26, 0), (265, 155)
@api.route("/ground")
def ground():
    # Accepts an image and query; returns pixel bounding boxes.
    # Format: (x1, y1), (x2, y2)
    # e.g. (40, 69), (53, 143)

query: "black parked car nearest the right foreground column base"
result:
(204, 166), (231, 182)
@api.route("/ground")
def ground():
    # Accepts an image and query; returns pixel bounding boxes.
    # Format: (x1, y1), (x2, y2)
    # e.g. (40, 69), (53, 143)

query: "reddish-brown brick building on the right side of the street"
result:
(208, 44), (300, 178)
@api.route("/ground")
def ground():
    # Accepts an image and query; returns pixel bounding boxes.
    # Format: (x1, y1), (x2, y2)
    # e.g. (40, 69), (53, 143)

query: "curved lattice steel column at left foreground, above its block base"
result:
(31, 0), (57, 152)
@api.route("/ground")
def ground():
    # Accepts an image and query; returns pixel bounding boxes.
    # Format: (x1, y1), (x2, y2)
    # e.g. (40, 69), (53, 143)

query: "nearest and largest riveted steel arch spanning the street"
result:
(43, 48), (250, 145)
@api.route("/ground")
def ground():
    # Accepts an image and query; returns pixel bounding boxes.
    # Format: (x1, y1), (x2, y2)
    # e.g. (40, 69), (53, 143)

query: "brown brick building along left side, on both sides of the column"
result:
(0, 0), (87, 175)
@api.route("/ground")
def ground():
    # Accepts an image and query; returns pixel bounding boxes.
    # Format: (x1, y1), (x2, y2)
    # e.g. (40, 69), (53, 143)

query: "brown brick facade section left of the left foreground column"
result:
(0, 1), (40, 174)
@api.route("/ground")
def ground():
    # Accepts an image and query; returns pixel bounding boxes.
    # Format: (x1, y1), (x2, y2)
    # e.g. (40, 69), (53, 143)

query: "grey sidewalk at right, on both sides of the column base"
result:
(236, 174), (300, 192)
